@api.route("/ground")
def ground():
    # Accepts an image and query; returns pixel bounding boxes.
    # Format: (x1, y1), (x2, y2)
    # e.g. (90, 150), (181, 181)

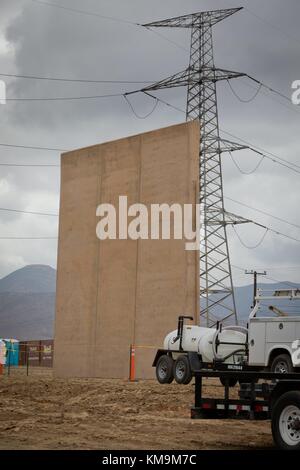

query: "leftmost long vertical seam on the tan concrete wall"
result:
(92, 148), (103, 373)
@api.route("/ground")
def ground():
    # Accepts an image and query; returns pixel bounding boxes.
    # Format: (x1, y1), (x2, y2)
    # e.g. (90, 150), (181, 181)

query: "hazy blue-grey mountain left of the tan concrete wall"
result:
(0, 265), (56, 341)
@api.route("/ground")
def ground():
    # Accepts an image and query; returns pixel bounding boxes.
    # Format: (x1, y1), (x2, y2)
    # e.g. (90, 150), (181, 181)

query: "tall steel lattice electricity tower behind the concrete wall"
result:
(142, 8), (249, 326)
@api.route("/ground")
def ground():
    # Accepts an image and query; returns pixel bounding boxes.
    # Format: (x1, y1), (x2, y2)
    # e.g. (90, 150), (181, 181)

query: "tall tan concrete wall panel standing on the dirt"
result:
(54, 122), (199, 378)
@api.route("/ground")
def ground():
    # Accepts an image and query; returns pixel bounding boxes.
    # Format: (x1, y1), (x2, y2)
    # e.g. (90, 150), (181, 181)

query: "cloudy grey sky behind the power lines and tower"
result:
(0, 0), (300, 285)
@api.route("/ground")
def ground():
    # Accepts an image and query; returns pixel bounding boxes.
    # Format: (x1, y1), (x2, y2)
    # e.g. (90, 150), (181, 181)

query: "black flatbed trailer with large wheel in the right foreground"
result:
(190, 366), (300, 450)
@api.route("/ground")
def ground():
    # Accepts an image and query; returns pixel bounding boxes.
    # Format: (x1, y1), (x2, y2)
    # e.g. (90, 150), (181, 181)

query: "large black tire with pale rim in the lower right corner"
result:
(271, 391), (300, 450)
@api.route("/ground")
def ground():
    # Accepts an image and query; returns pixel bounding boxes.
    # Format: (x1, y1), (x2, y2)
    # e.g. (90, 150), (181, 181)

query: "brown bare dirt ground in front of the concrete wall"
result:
(0, 369), (273, 450)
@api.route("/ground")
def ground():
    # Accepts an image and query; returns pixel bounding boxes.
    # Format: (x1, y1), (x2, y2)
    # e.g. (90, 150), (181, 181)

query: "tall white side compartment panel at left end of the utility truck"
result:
(249, 318), (266, 366)
